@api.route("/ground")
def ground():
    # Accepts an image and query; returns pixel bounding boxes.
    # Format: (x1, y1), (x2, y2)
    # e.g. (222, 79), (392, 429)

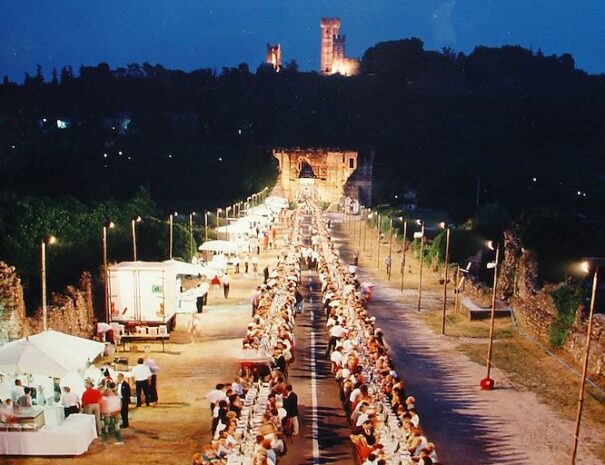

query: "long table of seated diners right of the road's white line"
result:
(312, 203), (438, 465)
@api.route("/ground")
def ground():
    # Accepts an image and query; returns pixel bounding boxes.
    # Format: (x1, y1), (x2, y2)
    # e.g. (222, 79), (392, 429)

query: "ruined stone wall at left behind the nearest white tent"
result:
(0, 262), (94, 340)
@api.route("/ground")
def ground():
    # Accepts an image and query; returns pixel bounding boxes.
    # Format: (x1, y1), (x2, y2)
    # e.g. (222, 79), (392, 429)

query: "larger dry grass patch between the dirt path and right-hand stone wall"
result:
(457, 336), (605, 463)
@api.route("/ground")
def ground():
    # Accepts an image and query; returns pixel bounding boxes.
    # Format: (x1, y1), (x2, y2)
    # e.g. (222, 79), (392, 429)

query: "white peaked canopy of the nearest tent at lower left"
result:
(0, 331), (104, 377)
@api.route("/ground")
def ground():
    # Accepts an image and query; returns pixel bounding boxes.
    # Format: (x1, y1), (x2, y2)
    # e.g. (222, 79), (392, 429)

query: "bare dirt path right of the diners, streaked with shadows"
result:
(335, 216), (602, 465)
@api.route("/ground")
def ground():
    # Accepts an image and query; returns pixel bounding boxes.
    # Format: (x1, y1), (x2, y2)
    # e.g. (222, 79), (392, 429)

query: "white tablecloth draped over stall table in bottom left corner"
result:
(0, 413), (97, 455)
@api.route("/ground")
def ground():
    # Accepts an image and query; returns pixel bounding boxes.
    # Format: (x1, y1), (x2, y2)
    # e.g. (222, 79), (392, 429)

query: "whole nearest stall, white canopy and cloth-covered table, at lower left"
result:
(0, 330), (105, 455)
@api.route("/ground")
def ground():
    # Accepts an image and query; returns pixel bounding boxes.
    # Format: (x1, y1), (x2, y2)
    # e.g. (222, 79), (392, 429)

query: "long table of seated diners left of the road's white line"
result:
(193, 210), (302, 465)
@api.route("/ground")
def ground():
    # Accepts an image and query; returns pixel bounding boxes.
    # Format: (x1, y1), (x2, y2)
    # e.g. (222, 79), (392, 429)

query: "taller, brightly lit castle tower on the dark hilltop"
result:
(320, 18), (359, 76)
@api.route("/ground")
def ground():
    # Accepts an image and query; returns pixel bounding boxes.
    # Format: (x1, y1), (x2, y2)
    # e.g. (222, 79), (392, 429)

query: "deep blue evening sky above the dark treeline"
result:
(0, 0), (605, 82)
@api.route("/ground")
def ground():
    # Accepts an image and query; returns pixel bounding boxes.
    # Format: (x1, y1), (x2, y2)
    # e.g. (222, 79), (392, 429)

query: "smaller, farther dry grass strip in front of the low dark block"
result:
(420, 311), (515, 339)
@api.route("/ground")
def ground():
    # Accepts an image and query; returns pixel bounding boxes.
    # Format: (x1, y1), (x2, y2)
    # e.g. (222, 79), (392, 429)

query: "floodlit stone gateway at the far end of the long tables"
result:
(273, 148), (374, 206)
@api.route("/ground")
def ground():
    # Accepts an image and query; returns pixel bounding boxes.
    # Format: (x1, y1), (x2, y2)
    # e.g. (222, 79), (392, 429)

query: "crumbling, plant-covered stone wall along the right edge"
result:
(463, 227), (605, 381)
